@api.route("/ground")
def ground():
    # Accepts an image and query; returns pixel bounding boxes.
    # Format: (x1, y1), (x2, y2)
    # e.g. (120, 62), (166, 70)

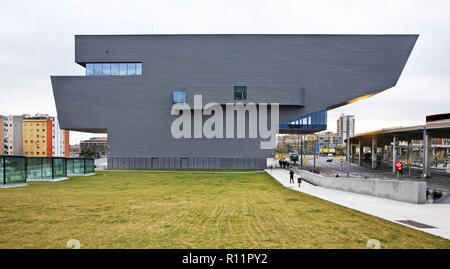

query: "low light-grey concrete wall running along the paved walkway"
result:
(300, 170), (427, 204)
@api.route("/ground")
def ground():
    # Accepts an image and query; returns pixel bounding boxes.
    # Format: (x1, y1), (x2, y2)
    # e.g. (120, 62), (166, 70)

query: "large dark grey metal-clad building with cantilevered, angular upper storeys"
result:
(51, 35), (418, 169)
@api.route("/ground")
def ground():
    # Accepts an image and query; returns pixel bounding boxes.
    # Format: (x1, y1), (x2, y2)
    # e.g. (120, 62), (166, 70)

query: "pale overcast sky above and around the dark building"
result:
(0, 0), (450, 144)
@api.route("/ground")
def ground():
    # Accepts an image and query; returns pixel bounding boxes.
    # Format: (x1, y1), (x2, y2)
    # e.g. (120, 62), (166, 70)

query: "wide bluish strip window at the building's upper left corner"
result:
(86, 63), (142, 76)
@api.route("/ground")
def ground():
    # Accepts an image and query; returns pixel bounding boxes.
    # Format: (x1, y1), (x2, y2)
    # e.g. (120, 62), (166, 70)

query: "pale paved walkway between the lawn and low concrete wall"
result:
(266, 169), (450, 240)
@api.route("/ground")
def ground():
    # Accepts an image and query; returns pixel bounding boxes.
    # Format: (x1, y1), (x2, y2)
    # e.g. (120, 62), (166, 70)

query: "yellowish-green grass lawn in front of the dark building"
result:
(0, 172), (450, 248)
